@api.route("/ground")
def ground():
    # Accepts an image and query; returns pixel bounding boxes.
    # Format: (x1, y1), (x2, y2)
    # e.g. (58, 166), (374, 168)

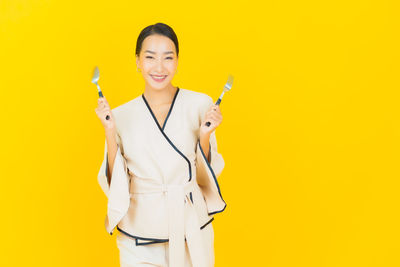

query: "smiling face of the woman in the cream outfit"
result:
(136, 34), (178, 90)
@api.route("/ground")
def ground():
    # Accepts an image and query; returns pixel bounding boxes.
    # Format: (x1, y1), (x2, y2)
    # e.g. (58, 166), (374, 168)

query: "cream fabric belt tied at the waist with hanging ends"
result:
(130, 176), (210, 267)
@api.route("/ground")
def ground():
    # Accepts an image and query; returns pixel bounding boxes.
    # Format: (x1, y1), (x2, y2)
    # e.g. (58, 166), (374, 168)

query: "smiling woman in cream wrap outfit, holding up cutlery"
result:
(96, 23), (226, 267)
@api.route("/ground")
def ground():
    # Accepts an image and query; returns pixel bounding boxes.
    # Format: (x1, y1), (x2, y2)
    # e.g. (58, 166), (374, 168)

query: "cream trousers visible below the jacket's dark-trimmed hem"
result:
(116, 223), (215, 267)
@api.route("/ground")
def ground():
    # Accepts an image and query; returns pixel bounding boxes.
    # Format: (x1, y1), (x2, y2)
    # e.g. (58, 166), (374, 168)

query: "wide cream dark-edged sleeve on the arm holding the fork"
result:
(196, 96), (226, 214)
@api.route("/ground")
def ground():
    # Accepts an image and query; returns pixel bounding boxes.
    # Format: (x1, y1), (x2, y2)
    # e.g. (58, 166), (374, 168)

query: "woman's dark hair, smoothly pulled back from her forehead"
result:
(136, 22), (179, 56)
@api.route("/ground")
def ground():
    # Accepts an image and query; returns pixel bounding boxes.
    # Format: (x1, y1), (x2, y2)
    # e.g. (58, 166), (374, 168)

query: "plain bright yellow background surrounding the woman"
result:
(0, 0), (400, 267)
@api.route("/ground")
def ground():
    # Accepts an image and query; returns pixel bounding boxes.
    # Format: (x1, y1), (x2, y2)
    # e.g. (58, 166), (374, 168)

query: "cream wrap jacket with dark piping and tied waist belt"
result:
(98, 88), (226, 267)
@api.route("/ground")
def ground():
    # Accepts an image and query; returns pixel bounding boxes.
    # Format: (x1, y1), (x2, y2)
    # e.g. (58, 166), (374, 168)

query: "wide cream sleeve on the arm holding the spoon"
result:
(98, 131), (130, 234)
